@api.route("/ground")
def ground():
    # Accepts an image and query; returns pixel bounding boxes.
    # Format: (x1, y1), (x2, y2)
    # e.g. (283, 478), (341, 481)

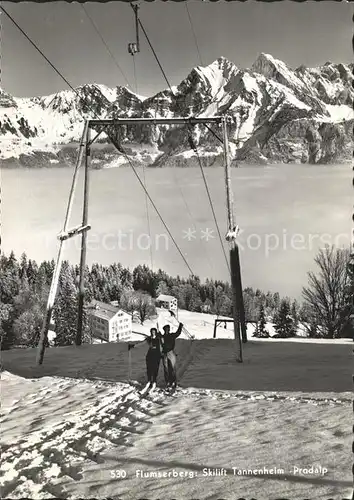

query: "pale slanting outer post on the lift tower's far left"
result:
(37, 122), (88, 365)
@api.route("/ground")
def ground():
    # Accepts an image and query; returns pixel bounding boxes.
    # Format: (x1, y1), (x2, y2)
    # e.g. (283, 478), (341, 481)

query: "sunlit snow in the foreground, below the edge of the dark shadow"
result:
(1, 366), (352, 500)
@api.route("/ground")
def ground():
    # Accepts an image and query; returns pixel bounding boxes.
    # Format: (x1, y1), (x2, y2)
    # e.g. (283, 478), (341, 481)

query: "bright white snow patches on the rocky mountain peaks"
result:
(0, 54), (353, 163)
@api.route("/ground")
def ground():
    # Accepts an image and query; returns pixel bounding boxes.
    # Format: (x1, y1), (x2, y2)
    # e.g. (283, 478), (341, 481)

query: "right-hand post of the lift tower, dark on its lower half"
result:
(222, 118), (242, 363)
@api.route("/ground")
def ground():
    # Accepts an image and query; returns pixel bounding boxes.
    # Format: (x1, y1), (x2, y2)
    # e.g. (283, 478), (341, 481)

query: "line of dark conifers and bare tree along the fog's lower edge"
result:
(0, 247), (354, 349)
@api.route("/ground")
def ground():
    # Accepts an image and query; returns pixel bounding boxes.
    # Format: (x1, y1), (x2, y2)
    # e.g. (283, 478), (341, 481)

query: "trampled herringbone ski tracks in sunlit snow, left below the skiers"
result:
(1, 379), (166, 498)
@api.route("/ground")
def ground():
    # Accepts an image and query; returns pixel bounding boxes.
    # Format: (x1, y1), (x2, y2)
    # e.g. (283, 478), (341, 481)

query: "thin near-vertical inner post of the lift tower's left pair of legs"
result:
(75, 128), (91, 346)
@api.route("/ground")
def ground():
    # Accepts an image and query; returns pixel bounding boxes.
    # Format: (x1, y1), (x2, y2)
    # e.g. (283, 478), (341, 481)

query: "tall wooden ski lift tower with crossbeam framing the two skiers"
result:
(37, 116), (244, 364)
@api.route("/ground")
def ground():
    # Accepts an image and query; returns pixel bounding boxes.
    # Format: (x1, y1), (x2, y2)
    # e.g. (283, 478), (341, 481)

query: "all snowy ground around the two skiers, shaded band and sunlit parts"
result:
(1, 310), (352, 500)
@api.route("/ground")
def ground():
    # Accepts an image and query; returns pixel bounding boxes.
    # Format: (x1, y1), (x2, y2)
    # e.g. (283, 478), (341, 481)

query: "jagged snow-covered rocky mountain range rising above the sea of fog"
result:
(0, 54), (354, 167)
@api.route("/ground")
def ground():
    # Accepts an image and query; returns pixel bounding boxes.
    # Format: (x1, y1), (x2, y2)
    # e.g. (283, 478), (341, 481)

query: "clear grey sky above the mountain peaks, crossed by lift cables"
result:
(1, 0), (353, 97)
